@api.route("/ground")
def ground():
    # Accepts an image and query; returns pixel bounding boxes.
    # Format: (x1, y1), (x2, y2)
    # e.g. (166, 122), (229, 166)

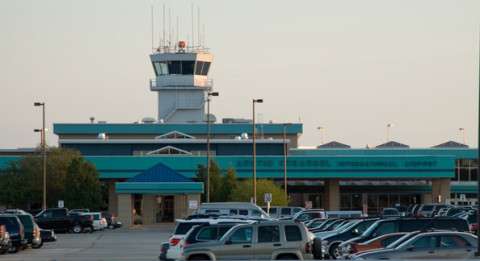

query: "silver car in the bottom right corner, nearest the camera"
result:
(352, 231), (478, 260)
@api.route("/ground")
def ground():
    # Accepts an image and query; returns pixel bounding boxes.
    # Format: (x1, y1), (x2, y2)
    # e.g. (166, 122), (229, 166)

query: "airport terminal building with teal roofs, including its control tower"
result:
(0, 43), (478, 226)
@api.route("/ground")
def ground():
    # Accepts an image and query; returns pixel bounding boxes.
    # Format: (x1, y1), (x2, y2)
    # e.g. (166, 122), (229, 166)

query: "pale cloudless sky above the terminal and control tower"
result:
(0, 0), (480, 149)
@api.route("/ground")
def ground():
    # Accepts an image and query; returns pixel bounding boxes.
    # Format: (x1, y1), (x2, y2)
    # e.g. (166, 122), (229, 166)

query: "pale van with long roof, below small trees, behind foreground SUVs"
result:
(197, 202), (270, 218)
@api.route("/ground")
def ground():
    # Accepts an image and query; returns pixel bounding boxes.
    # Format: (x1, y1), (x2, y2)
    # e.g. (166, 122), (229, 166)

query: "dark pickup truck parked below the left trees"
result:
(35, 208), (93, 233)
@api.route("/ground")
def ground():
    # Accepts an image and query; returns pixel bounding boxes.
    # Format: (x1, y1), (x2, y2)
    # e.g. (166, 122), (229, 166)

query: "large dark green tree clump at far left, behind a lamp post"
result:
(0, 147), (102, 210)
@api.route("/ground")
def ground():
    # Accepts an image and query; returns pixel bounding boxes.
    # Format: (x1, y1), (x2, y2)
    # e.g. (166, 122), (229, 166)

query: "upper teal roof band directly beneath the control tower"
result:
(53, 123), (303, 135)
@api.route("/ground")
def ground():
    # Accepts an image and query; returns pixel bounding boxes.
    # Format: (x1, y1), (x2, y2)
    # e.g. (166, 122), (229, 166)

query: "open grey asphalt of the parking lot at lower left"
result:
(0, 224), (174, 260)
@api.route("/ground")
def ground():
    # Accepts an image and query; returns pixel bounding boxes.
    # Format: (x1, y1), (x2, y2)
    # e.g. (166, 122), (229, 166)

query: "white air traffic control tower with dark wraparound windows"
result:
(150, 41), (213, 124)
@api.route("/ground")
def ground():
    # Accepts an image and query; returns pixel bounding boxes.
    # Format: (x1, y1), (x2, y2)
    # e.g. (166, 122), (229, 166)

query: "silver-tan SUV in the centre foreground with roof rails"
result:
(182, 221), (313, 261)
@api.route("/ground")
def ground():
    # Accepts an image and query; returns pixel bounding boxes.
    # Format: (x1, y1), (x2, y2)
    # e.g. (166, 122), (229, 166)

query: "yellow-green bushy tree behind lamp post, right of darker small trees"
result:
(232, 179), (289, 206)
